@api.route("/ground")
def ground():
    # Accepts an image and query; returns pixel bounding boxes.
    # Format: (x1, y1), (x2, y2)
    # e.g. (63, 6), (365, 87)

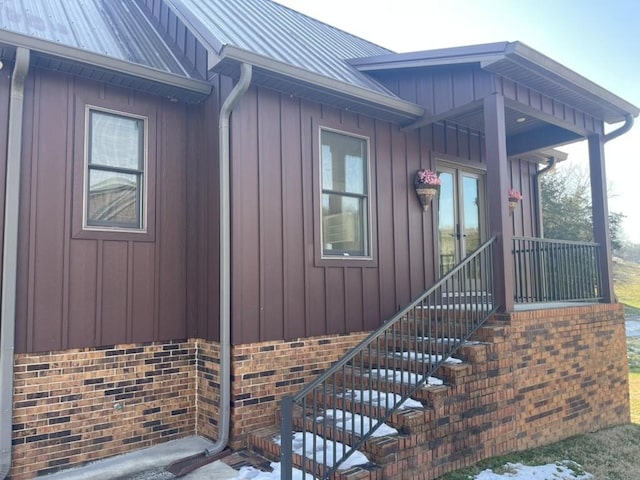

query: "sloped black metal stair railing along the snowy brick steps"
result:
(280, 238), (497, 480)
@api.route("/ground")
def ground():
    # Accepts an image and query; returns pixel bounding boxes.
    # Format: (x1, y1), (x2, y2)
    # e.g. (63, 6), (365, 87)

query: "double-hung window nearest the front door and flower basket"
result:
(320, 130), (370, 257)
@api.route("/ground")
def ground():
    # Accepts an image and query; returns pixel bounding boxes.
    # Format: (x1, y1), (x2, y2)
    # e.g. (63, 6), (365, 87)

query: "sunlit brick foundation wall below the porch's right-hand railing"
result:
(509, 305), (630, 450)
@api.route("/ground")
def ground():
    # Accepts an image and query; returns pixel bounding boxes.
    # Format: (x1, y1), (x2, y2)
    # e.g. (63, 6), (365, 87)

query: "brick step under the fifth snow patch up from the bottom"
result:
(351, 351), (472, 384)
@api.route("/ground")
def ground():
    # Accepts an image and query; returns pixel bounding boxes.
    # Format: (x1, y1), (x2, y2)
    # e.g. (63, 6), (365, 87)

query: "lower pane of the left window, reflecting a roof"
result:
(87, 169), (141, 228)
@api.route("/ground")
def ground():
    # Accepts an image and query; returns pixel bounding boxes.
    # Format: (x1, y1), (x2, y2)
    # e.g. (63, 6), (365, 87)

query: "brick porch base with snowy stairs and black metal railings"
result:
(272, 237), (628, 480)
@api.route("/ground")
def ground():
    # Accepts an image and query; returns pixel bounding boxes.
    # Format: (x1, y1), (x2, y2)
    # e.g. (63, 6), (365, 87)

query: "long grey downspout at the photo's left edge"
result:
(0, 47), (29, 479)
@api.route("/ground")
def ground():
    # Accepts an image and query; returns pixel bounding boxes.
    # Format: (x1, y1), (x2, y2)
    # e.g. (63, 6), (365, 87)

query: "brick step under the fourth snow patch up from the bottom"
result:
(335, 366), (450, 407)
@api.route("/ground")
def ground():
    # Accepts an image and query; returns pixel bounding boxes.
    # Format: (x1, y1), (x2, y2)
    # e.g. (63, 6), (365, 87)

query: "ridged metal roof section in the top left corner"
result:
(0, 0), (188, 77)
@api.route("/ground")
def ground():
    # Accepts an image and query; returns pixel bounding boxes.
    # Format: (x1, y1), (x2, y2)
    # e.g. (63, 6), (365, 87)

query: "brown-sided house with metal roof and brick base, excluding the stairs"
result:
(0, 0), (639, 479)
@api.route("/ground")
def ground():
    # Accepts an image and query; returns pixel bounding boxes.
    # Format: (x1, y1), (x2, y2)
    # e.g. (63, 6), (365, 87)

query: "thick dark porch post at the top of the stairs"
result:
(484, 93), (514, 312)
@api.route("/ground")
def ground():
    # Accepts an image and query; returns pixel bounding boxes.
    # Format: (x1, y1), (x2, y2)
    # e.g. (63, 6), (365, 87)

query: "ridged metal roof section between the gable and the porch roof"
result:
(169, 0), (395, 96)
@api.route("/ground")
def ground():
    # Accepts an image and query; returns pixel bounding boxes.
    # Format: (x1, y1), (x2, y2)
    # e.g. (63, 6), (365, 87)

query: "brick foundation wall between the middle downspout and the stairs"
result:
(230, 333), (367, 447)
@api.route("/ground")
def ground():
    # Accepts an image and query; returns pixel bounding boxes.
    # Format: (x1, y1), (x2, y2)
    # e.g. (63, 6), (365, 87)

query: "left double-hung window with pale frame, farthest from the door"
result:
(85, 109), (146, 231)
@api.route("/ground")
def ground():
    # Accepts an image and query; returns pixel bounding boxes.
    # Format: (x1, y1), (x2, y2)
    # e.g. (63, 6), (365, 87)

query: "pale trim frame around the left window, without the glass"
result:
(82, 104), (149, 234)
